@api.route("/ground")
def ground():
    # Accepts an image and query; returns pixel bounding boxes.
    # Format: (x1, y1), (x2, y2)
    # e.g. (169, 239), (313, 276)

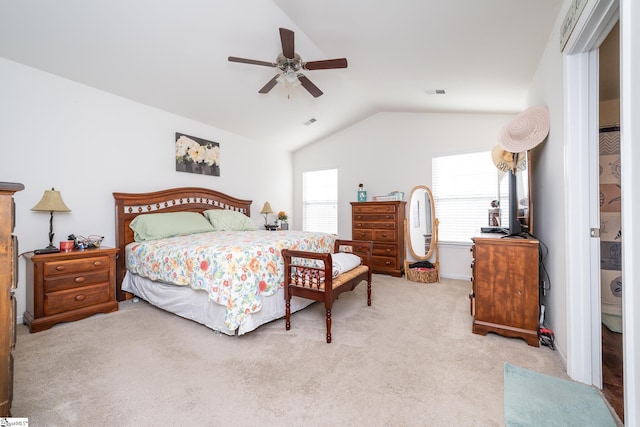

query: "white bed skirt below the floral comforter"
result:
(122, 272), (313, 335)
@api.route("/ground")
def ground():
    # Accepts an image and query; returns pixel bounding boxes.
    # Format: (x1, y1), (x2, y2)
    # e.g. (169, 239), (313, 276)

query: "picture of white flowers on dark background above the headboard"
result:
(176, 132), (220, 176)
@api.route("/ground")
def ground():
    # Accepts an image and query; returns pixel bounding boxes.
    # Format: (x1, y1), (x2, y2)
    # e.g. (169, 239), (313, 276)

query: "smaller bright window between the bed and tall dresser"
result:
(302, 169), (338, 234)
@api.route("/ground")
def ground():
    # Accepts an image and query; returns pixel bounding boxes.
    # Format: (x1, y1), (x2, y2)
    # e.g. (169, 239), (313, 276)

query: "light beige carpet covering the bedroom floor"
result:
(13, 274), (566, 427)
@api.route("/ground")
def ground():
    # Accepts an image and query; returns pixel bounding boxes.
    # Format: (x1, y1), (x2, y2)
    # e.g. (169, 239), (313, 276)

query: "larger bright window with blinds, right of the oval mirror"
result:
(431, 151), (498, 243)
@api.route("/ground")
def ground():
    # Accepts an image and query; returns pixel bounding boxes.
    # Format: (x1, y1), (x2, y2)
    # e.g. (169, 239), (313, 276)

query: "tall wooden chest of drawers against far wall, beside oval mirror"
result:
(351, 202), (406, 277)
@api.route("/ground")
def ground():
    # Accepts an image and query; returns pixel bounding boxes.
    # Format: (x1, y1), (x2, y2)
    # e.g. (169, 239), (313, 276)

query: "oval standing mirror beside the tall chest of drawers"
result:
(407, 185), (436, 261)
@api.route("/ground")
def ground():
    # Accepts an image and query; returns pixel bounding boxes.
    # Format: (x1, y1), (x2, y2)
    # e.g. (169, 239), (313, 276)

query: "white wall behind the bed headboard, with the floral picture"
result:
(0, 58), (295, 321)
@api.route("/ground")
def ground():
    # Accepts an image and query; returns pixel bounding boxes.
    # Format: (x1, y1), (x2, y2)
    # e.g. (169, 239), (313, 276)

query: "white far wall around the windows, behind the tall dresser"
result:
(293, 113), (514, 279)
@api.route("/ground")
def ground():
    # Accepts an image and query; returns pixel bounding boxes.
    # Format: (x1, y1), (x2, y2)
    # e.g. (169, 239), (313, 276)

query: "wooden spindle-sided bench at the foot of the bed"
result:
(282, 239), (373, 343)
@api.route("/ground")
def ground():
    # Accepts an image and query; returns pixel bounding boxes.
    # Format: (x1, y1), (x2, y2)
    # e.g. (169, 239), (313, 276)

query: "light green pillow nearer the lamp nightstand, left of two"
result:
(129, 212), (215, 242)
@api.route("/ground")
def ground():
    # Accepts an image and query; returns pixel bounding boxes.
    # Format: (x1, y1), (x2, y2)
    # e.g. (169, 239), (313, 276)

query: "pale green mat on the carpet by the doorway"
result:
(504, 363), (616, 427)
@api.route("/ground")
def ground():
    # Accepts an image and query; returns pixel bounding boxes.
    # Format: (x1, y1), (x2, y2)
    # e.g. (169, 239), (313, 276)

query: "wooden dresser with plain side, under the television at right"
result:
(469, 237), (540, 347)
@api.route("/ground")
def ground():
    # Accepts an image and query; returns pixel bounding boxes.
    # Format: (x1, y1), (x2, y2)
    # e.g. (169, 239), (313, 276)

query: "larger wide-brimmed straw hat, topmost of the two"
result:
(500, 106), (549, 153)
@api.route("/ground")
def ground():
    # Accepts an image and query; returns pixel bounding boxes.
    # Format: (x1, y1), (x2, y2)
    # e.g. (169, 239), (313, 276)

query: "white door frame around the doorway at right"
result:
(563, 0), (640, 425)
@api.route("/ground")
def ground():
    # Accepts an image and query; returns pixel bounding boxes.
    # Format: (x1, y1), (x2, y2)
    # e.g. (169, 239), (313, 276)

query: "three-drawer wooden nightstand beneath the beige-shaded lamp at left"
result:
(24, 248), (118, 332)
